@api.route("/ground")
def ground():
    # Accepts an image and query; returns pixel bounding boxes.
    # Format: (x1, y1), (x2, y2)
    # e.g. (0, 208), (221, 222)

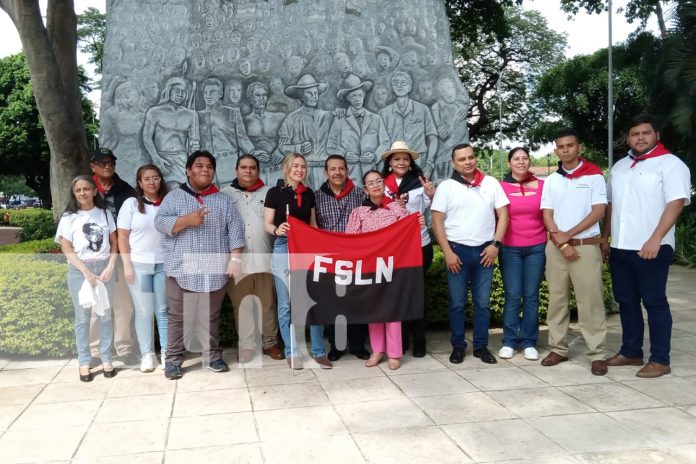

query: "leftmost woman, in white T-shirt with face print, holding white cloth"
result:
(55, 176), (118, 382)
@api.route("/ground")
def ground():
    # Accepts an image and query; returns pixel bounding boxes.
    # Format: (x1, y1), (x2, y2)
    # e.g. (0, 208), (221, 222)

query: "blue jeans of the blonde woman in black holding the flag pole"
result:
(271, 237), (326, 358)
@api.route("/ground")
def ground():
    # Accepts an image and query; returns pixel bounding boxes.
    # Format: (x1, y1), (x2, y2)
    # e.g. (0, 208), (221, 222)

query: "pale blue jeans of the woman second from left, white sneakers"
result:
(128, 262), (168, 356)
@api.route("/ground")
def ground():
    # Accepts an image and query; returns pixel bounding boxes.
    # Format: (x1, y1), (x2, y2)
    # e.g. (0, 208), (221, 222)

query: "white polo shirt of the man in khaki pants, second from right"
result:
(541, 166), (607, 239)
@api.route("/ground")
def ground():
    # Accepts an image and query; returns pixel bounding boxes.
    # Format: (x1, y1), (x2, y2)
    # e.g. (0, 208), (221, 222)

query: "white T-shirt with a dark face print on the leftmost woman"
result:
(55, 207), (116, 260)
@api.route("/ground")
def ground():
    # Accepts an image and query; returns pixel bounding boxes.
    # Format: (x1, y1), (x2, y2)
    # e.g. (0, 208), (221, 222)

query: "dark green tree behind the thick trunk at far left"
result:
(0, 53), (97, 206)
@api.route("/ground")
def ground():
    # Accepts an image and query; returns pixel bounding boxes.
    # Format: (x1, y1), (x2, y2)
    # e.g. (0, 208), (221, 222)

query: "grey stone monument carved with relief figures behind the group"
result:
(100, 0), (469, 188)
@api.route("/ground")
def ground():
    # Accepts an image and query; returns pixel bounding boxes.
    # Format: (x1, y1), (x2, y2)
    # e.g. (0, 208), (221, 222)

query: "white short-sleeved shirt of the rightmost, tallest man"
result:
(607, 155), (691, 250)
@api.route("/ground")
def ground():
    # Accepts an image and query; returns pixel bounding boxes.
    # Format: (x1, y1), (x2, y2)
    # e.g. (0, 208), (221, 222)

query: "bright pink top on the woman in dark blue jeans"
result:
(500, 180), (546, 247)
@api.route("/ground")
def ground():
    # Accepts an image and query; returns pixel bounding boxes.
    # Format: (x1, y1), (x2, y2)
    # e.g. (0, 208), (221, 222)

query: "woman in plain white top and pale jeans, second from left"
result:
(118, 164), (168, 372)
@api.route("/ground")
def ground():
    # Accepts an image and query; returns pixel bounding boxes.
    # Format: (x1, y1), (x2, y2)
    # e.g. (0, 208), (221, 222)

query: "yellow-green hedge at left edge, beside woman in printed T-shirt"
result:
(0, 253), (75, 357)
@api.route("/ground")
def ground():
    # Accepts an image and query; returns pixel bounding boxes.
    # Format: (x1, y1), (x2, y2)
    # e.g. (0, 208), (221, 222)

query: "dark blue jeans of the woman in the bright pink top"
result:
(500, 243), (546, 349)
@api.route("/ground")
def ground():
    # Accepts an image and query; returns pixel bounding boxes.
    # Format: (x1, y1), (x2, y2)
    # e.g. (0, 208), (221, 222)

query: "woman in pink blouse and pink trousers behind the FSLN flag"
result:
(346, 170), (425, 370)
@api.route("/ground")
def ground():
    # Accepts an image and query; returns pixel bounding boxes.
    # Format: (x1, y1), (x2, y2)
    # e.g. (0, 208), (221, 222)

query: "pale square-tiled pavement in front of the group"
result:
(0, 267), (696, 464)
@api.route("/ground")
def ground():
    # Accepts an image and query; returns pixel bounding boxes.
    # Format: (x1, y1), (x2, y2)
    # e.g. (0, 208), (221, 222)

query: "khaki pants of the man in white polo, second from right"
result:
(546, 241), (607, 361)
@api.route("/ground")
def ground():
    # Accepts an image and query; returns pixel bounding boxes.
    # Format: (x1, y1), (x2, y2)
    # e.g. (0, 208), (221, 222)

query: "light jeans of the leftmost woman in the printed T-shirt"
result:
(68, 259), (114, 366)
